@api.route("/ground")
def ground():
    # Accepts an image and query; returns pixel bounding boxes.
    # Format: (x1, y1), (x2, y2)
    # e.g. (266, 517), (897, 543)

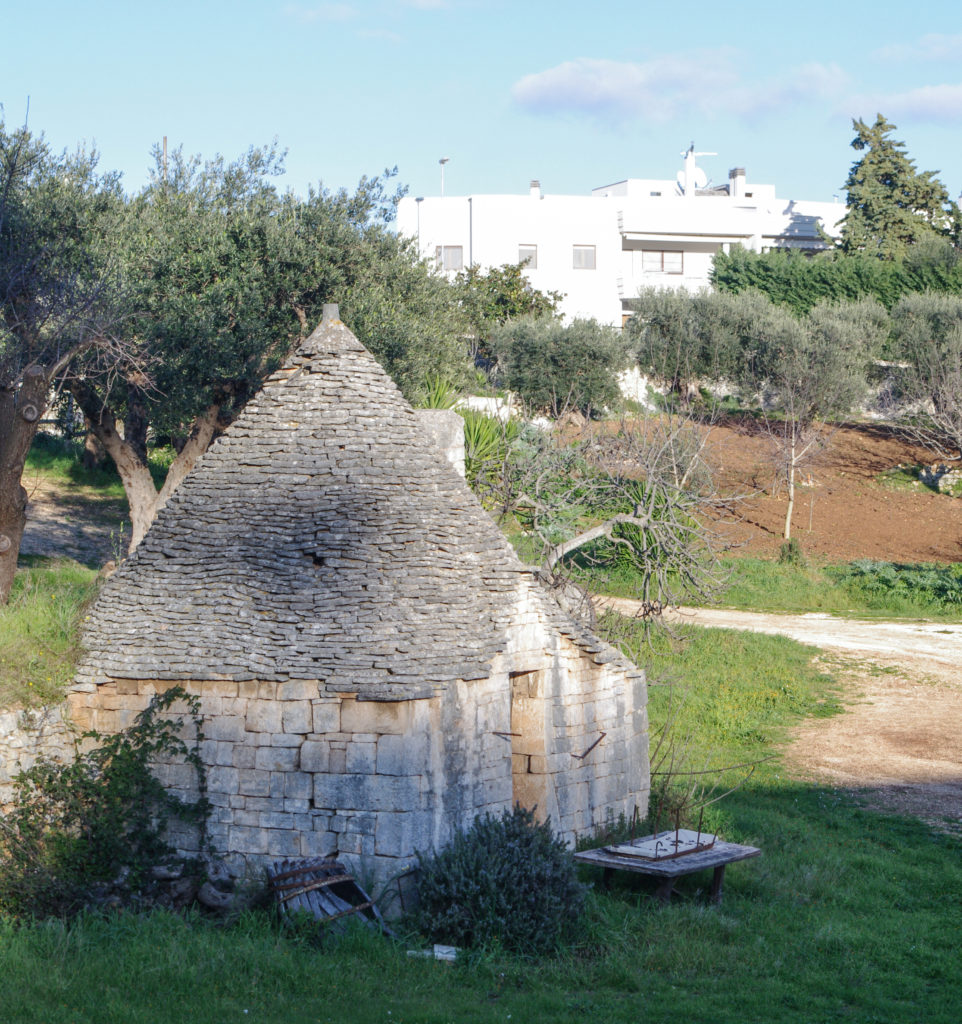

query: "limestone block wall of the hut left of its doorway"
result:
(70, 679), (511, 882)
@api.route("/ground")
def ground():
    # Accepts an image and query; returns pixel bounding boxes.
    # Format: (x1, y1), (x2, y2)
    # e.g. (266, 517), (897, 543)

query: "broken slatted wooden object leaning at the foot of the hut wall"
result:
(267, 857), (393, 935)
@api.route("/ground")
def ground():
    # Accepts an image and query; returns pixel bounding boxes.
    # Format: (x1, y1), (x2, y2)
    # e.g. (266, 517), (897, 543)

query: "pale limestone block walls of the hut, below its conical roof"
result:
(61, 631), (647, 882)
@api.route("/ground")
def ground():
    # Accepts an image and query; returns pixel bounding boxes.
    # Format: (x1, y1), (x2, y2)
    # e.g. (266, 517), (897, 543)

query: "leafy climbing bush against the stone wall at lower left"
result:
(0, 687), (207, 918)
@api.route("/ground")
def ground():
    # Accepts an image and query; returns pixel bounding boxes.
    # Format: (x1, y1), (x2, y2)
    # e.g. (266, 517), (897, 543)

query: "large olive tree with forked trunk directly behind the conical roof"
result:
(71, 146), (467, 550)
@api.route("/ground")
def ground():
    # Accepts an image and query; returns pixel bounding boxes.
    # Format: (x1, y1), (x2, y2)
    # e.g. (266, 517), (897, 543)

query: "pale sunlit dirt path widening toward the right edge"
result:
(607, 598), (962, 834)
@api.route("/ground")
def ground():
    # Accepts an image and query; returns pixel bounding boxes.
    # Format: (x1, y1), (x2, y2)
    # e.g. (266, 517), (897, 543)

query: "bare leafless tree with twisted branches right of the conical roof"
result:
(475, 413), (722, 621)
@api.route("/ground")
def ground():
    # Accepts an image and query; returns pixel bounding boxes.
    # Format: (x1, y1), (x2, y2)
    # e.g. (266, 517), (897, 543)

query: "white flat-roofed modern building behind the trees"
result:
(398, 146), (845, 326)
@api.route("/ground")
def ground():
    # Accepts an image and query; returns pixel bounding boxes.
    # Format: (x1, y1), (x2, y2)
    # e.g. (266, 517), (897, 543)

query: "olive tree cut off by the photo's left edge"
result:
(0, 120), (124, 601)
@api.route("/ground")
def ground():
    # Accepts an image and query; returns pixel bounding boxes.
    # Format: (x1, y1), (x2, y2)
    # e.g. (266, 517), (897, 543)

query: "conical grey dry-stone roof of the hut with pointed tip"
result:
(78, 307), (627, 699)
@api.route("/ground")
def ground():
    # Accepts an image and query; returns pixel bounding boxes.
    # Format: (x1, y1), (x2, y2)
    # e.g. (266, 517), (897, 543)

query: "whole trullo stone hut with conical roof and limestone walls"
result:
(70, 307), (649, 878)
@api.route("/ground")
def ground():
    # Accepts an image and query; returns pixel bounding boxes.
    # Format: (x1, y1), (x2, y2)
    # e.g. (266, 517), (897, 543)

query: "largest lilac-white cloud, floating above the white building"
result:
(511, 49), (848, 122)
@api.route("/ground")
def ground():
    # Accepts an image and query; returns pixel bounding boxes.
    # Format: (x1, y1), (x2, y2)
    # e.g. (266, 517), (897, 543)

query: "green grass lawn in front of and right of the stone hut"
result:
(0, 622), (962, 1024)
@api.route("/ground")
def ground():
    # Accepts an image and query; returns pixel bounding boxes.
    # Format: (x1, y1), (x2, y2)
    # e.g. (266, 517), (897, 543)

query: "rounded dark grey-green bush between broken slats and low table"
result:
(417, 806), (585, 952)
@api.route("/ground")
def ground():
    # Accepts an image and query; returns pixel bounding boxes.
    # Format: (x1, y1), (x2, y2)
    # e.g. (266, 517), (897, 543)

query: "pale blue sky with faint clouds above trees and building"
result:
(0, 0), (962, 207)
